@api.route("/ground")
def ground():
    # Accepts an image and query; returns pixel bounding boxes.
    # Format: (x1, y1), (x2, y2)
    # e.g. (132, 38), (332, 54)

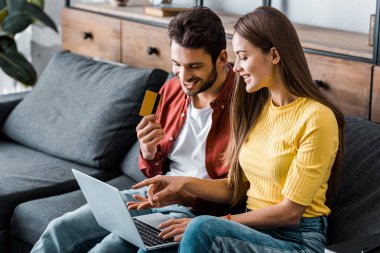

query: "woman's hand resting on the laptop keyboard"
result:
(158, 218), (192, 242)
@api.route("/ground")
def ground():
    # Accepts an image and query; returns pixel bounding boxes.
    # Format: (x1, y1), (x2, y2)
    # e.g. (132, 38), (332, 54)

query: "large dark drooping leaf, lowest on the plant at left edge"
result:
(0, 36), (37, 86)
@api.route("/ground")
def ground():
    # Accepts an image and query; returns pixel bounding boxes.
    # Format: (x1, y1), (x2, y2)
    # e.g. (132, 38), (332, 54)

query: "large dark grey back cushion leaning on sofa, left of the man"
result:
(3, 52), (167, 167)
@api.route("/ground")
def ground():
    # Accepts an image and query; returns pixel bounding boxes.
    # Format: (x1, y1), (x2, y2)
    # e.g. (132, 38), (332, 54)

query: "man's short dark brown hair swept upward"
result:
(168, 7), (226, 63)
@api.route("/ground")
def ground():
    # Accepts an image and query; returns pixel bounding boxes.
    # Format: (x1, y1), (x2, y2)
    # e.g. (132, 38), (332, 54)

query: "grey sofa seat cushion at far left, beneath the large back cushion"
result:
(0, 141), (121, 231)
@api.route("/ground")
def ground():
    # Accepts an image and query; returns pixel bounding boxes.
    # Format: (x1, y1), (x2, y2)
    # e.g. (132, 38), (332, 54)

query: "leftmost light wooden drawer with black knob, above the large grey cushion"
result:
(61, 8), (121, 62)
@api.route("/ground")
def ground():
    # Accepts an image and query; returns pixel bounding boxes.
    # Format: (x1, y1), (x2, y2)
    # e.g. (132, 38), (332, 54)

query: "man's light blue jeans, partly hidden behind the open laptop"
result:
(31, 188), (195, 253)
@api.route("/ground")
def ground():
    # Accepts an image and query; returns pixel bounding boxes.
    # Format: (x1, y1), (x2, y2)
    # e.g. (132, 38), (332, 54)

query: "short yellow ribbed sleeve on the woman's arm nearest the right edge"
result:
(282, 109), (339, 206)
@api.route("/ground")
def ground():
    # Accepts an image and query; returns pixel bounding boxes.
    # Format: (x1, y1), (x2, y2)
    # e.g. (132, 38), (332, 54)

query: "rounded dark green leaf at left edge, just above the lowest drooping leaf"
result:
(2, 12), (33, 34)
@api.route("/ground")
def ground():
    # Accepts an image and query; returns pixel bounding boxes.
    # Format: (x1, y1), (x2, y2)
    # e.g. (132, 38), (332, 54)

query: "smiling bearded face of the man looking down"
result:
(171, 41), (218, 96)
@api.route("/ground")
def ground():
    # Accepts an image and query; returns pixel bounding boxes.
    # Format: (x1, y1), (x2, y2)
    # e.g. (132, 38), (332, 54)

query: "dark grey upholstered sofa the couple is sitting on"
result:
(0, 52), (380, 253)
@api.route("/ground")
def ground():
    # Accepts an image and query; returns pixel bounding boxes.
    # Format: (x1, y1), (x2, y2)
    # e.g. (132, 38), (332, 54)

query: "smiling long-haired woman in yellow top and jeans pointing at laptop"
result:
(136, 7), (344, 252)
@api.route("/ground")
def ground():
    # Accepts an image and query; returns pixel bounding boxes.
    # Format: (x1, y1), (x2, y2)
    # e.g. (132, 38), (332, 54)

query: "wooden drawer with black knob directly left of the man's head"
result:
(122, 20), (172, 72)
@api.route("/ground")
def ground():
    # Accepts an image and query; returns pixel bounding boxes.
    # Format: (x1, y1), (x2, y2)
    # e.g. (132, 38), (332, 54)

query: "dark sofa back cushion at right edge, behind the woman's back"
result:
(328, 118), (380, 244)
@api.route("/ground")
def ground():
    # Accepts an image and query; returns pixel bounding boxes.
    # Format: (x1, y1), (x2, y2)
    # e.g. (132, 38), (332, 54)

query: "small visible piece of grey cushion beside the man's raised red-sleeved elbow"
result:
(121, 141), (146, 182)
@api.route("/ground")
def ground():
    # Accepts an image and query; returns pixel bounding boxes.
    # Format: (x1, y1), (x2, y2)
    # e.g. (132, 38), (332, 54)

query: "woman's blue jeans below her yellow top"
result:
(179, 216), (327, 253)
